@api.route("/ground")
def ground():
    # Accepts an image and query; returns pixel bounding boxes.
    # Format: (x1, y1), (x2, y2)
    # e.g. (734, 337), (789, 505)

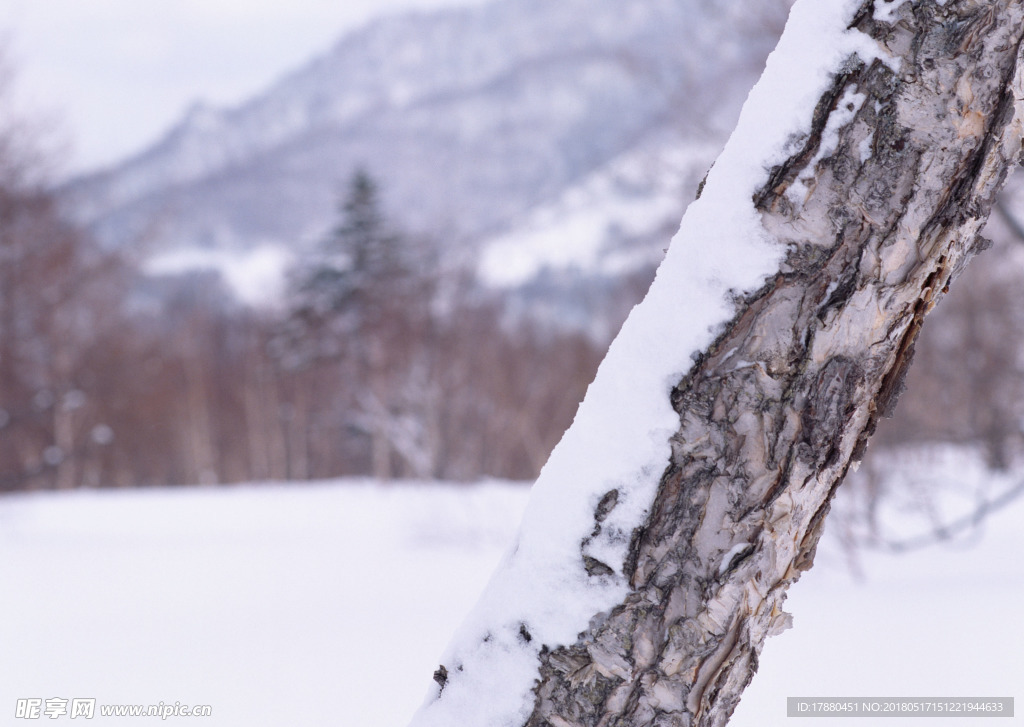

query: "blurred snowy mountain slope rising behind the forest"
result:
(66, 0), (787, 301)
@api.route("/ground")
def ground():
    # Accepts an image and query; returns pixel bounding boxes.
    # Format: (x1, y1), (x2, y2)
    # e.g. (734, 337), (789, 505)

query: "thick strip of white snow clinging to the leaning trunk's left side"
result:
(412, 0), (892, 727)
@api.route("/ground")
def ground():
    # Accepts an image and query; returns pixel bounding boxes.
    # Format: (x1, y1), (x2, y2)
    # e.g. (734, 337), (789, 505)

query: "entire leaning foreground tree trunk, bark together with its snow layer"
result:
(413, 0), (1024, 727)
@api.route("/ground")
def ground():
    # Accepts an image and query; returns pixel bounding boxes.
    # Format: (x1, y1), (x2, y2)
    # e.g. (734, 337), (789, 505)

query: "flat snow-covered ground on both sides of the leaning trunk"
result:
(0, 481), (1024, 727)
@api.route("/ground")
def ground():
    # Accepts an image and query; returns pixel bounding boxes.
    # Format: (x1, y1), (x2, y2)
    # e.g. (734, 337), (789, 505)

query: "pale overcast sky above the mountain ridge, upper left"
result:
(0, 0), (485, 173)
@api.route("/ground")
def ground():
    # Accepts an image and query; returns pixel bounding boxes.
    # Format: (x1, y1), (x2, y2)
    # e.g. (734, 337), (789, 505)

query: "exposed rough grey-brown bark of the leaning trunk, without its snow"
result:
(414, 0), (1024, 727)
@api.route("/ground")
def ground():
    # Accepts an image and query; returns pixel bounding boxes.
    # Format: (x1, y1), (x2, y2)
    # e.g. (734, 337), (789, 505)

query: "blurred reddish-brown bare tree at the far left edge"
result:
(0, 156), (123, 488)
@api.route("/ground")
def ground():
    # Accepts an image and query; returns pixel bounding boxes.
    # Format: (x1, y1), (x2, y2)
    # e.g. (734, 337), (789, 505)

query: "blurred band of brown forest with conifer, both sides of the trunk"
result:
(0, 42), (1024, 491)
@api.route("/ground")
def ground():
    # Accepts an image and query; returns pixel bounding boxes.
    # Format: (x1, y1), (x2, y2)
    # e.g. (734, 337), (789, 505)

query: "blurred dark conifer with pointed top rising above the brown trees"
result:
(278, 169), (426, 479)
